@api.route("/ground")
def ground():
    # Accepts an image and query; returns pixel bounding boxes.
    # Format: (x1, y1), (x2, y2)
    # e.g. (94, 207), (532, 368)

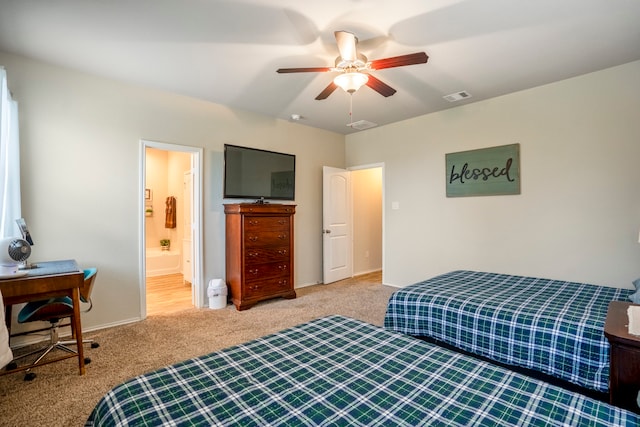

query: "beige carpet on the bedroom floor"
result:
(0, 273), (394, 427)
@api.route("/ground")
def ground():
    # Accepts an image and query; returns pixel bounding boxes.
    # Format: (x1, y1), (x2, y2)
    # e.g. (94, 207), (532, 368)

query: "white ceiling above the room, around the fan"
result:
(0, 0), (640, 134)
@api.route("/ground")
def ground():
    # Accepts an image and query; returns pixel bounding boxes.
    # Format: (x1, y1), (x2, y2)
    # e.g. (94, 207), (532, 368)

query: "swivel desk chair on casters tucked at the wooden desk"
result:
(14, 268), (100, 381)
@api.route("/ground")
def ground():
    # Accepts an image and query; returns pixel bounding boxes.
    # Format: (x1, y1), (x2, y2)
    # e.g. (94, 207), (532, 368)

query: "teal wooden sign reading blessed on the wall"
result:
(445, 144), (520, 197)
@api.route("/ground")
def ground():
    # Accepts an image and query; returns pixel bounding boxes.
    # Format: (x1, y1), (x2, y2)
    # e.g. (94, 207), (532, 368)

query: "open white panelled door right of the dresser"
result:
(322, 166), (353, 284)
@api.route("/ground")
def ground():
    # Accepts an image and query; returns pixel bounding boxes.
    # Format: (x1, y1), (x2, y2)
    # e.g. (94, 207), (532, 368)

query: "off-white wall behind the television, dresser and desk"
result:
(0, 52), (344, 329)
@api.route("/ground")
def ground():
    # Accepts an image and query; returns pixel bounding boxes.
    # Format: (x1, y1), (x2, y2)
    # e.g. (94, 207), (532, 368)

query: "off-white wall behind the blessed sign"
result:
(346, 62), (640, 288)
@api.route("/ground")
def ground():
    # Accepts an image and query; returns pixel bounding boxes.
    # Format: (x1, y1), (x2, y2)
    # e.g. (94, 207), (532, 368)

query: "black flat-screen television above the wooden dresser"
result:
(223, 144), (296, 200)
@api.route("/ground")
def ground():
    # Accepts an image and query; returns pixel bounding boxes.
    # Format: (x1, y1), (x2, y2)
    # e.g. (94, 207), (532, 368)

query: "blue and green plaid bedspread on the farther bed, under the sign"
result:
(384, 271), (633, 392)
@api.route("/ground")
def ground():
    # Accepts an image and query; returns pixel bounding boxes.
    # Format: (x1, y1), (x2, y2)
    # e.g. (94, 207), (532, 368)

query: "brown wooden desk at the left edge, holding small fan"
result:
(0, 260), (85, 375)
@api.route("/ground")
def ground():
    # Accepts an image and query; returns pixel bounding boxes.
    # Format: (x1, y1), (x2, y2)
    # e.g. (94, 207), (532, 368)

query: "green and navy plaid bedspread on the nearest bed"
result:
(86, 316), (640, 426)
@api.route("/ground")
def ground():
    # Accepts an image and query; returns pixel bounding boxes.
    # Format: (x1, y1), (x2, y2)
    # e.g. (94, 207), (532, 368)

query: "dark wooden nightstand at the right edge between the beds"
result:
(604, 301), (640, 414)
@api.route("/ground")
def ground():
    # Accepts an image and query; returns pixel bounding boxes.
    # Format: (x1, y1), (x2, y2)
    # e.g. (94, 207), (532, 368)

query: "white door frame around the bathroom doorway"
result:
(138, 139), (204, 319)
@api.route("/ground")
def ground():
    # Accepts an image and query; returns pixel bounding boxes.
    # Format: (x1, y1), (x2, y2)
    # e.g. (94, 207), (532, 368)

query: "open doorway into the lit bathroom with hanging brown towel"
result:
(140, 141), (202, 318)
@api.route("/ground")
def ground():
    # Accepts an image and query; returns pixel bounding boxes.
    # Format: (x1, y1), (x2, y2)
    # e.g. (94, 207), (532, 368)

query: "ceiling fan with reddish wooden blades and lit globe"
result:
(276, 31), (429, 100)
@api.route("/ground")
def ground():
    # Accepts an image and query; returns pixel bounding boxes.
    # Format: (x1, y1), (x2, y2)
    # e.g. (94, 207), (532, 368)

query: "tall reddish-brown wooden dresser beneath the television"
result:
(224, 203), (296, 310)
